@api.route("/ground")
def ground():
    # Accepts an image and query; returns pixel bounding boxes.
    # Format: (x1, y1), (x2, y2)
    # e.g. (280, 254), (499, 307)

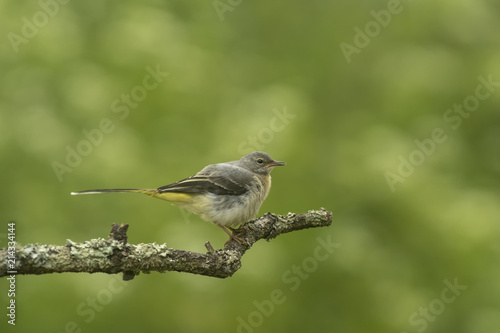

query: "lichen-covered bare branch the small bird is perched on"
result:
(0, 208), (332, 280)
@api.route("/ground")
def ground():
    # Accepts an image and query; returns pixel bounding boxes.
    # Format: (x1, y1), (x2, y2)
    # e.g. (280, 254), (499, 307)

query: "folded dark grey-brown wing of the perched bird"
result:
(158, 164), (253, 195)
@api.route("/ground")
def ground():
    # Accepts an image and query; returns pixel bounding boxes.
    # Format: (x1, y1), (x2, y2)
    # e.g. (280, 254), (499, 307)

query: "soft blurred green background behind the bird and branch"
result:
(0, 0), (500, 333)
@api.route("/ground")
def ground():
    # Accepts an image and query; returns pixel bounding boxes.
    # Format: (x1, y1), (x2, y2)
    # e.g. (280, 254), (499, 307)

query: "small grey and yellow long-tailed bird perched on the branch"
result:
(71, 151), (285, 244)
